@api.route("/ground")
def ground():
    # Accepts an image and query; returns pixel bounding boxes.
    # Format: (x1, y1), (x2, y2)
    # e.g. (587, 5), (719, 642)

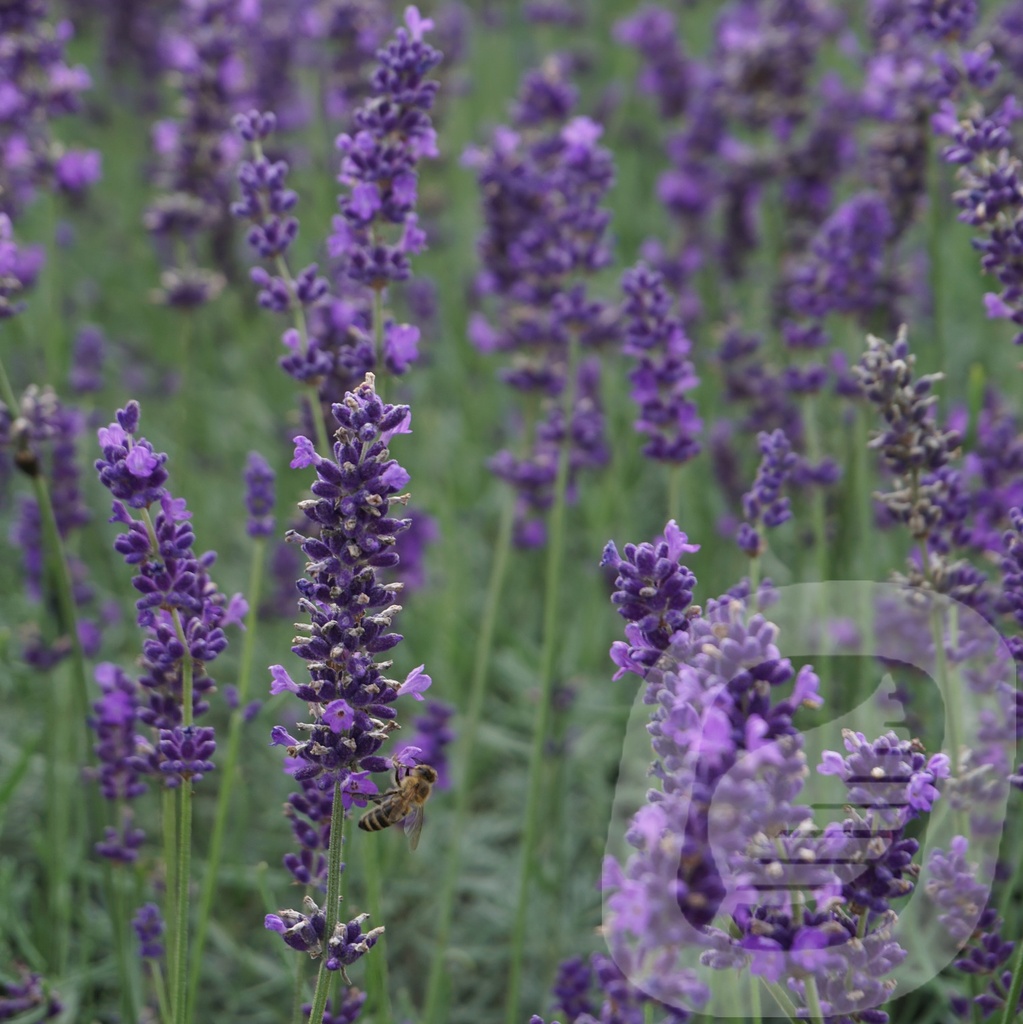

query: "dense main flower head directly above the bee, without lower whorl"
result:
(270, 376), (429, 791)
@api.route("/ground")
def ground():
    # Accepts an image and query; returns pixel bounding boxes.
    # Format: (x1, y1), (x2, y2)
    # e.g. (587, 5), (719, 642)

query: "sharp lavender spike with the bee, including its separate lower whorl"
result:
(265, 374), (430, 971)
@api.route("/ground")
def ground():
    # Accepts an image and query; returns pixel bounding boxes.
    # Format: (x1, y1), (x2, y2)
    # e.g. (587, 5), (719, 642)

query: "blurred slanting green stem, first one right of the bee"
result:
(424, 494), (515, 1024)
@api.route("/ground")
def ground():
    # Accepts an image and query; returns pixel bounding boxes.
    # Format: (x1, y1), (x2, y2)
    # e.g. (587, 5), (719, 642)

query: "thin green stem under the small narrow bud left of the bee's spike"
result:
(188, 537), (266, 1020)
